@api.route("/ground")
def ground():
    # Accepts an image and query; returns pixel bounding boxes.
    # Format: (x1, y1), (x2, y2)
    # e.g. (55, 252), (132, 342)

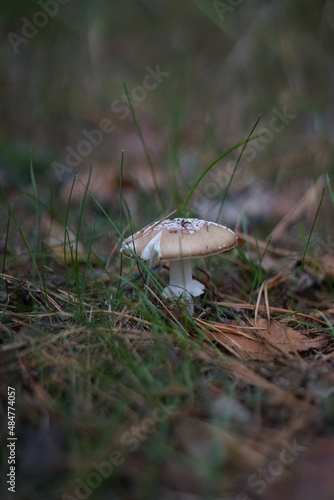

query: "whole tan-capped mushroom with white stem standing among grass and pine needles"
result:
(121, 218), (237, 299)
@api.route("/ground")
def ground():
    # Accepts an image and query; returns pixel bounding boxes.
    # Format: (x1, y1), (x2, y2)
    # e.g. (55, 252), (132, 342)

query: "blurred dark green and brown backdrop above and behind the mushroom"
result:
(0, 0), (334, 237)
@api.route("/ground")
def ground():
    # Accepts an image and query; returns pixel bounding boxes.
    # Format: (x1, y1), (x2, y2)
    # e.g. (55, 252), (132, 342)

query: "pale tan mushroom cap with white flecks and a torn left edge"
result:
(121, 218), (237, 260)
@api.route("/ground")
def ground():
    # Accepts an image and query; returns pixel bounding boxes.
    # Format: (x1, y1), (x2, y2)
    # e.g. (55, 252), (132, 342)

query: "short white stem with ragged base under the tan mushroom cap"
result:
(163, 259), (205, 298)
